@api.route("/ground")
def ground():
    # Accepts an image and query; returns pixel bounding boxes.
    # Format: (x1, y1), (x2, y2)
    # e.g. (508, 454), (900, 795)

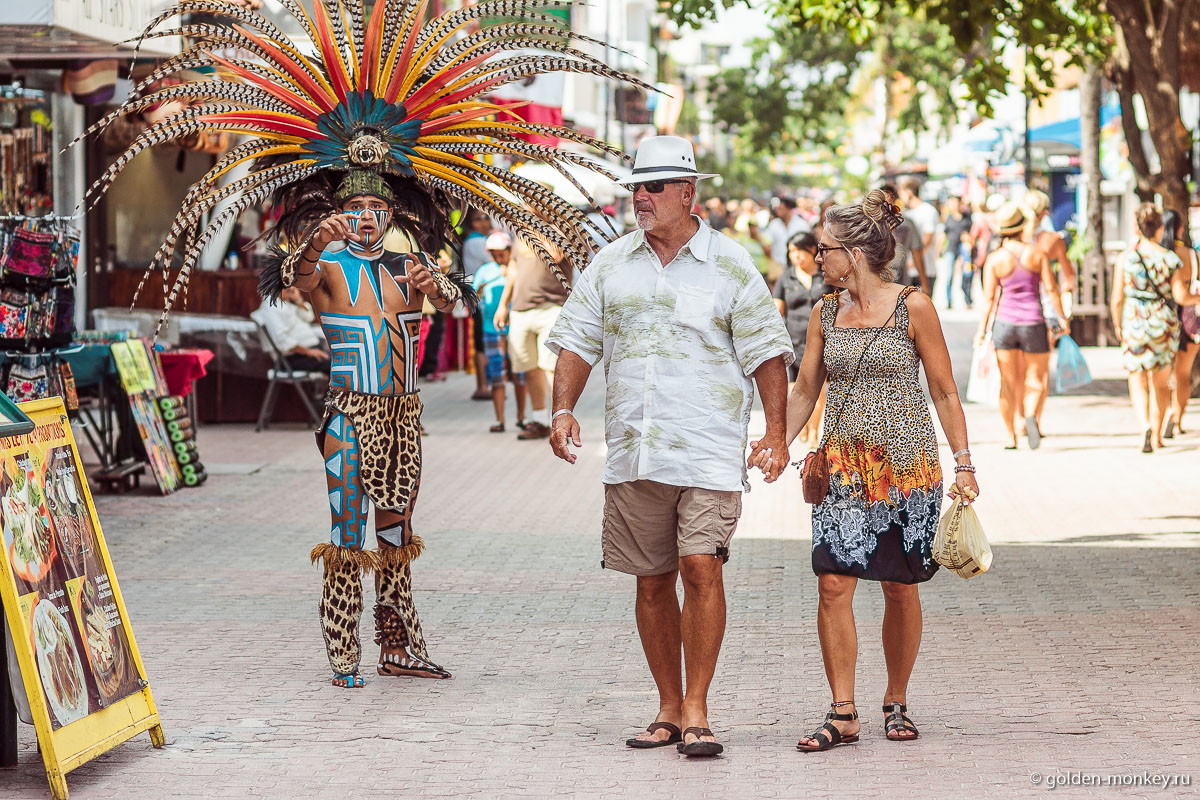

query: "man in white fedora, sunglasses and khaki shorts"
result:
(547, 136), (793, 756)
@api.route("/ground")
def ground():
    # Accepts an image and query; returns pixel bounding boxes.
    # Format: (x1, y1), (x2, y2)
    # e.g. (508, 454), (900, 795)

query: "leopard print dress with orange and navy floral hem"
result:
(812, 288), (942, 584)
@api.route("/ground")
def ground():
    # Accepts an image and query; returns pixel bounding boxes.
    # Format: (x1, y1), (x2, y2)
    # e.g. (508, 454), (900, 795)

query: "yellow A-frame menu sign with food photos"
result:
(0, 397), (164, 800)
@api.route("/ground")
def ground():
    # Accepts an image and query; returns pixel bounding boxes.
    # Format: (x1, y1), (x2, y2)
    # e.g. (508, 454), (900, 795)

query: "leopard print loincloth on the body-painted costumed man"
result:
(317, 386), (424, 513)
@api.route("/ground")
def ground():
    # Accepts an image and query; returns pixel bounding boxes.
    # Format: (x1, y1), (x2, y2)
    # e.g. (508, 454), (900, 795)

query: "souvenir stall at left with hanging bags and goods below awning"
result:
(0, 7), (211, 501)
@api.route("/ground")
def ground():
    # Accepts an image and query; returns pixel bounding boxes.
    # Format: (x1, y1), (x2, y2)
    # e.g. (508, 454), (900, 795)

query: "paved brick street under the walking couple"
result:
(7, 314), (1200, 799)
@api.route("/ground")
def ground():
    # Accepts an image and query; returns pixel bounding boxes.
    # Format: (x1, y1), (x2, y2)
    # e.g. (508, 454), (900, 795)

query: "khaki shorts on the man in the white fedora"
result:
(600, 481), (742, 576)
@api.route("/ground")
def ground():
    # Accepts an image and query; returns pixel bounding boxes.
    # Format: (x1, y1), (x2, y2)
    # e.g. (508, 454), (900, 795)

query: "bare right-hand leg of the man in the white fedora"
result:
(679, 555), (725, 744)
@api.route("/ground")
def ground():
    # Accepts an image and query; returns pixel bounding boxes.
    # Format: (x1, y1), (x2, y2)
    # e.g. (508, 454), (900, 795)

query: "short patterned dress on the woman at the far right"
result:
(1115, 242), (1183, 372)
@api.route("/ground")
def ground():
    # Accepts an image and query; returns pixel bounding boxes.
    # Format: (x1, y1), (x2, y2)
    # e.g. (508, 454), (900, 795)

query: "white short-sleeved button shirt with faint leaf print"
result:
(547, 217), (794, 491)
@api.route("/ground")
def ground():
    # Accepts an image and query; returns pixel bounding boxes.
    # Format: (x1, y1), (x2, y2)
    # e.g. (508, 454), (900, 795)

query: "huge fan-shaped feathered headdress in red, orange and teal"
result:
(80, 0), (652, 326)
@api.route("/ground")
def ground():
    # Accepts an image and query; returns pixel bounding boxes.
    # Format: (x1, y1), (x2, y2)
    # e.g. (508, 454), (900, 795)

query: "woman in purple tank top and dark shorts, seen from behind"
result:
(977, 203), (1069, 450)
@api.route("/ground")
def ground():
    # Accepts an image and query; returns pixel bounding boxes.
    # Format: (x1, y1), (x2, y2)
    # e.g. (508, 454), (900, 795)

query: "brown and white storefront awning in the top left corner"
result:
(0, 0), (179, 62)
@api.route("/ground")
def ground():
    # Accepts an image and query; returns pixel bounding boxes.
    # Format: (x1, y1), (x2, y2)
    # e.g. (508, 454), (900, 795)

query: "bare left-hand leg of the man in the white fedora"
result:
(635, 570), (683, 741)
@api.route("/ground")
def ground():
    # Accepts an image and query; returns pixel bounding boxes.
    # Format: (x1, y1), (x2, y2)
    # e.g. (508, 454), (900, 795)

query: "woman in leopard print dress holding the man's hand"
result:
(768, 191), (979, 751)
